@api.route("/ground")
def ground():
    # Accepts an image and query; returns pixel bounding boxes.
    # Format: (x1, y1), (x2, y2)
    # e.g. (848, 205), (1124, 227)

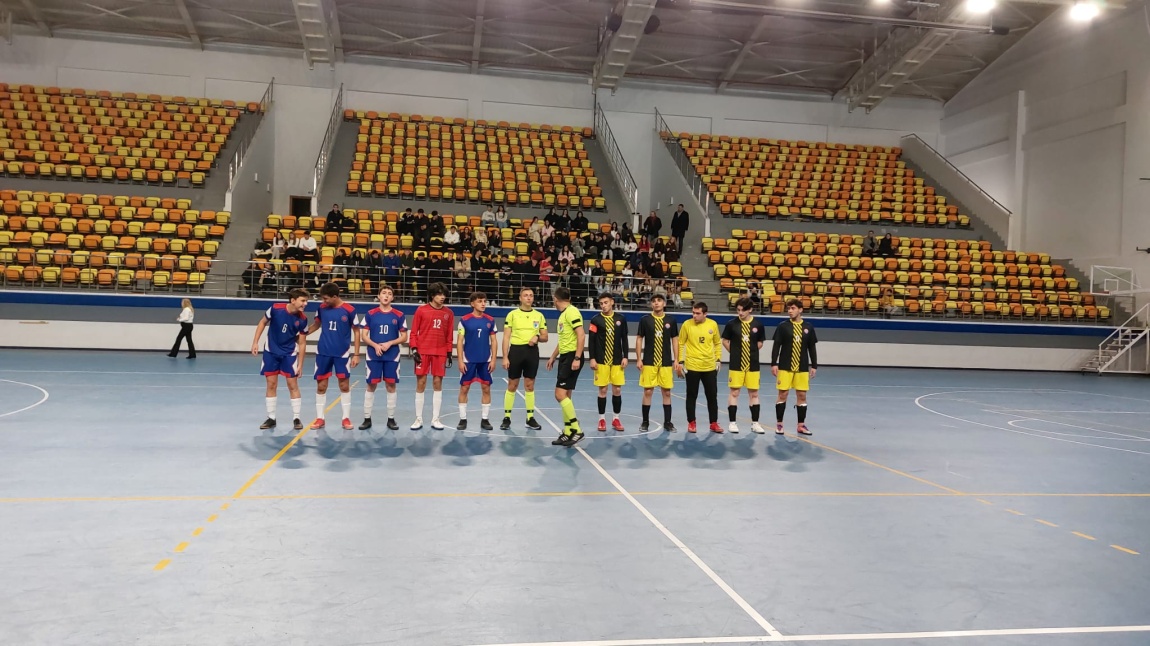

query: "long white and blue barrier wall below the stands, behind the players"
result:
(0, 291), (1111, 371)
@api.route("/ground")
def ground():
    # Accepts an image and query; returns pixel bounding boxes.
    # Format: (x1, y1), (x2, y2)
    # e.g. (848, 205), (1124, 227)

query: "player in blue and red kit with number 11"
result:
(307, 283), (360, 431)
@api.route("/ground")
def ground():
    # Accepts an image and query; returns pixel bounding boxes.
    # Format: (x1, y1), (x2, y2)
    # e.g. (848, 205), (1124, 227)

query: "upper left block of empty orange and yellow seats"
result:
(0, 83), (260, 186)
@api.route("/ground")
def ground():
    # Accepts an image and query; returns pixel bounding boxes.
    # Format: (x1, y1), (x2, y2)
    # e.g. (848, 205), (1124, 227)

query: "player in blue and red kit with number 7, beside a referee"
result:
(455, 292), (498, 431)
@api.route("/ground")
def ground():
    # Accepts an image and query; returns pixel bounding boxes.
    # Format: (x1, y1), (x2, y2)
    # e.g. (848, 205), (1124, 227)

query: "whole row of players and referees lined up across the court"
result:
(252, 283), (818, 446)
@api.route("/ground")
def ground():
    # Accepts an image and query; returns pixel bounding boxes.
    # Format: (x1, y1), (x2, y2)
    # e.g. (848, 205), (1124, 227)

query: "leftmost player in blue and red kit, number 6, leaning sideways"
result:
(252, 290), (312, 431)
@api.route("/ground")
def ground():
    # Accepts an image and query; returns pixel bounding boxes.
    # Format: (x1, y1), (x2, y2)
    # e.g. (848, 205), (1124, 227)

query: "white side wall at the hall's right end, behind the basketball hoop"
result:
(942, 7), (1150, 282)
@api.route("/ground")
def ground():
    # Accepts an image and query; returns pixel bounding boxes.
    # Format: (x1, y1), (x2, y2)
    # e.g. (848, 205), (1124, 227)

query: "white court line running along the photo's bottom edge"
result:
(462, 625), (1150, 646)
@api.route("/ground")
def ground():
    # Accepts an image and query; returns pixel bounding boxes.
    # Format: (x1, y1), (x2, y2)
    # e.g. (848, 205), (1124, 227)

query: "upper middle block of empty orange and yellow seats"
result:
(344, 110), (606, 210)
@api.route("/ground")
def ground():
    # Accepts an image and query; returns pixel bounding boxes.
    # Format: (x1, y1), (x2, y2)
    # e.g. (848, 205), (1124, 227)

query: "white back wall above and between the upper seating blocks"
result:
(0, 36), (942, 212)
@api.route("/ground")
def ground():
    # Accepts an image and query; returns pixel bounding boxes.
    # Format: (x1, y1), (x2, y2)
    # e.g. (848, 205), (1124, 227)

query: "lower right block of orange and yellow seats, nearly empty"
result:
(702, 230), (1111, 321)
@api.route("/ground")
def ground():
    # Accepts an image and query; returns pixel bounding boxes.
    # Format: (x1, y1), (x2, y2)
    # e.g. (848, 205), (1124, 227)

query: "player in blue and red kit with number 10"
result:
(359, 285), (407, 431)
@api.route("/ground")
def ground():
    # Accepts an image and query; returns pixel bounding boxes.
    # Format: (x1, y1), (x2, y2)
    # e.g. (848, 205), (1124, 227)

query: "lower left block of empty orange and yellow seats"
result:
(0, 190), (231, 286)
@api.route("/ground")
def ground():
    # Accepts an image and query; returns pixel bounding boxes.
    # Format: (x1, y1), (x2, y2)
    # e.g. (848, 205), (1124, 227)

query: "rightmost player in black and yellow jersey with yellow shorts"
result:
(771, 299), (819, 436)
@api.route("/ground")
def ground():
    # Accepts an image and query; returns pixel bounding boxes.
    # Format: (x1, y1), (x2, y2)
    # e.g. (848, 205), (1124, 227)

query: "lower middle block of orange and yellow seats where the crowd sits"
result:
(245, 209), (692, 305)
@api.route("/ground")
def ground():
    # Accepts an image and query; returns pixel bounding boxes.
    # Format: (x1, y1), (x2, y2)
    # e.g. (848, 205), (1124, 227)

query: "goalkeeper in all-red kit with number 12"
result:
(407, 283), (455, 431)
